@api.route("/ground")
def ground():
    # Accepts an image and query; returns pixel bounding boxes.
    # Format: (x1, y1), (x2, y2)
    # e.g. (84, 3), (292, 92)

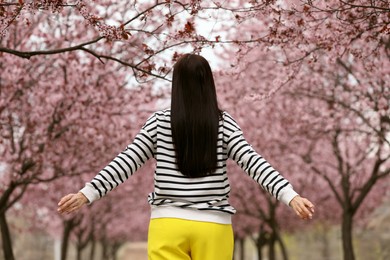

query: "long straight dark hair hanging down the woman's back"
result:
(171, 54), (221, 177)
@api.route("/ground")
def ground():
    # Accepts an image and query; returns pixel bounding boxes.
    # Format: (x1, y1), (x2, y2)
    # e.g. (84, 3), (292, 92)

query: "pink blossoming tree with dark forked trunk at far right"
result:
(218, 18), (390, 259)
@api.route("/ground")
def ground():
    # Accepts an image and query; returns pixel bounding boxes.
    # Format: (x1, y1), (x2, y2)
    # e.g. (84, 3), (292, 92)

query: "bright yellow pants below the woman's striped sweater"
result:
(148, 218), (234, 260)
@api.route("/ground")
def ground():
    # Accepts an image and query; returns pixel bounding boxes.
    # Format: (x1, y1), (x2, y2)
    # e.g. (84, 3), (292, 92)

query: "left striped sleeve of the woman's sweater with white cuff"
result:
(80, 116), (155, 203)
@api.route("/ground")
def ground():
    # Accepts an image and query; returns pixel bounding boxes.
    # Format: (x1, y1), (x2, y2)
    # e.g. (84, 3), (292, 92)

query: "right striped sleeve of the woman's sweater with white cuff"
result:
(226, 112), (298, 206)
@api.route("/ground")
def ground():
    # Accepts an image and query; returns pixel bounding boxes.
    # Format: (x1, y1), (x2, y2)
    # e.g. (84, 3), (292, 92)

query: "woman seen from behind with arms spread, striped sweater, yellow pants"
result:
(58, 54), (314, 260)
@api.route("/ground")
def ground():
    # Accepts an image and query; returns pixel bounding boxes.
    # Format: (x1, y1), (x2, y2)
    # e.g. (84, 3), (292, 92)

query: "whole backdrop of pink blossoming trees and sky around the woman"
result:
(0, 0), (390, 260)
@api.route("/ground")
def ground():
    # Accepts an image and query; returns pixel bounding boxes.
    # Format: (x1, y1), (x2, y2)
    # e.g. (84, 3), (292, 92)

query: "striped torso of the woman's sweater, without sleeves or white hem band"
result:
(143, 110), (239, 216)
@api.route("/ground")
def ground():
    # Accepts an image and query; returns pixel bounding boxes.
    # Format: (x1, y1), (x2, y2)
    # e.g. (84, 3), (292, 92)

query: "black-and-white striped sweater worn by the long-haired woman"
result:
(81, 110), (297, 223)
